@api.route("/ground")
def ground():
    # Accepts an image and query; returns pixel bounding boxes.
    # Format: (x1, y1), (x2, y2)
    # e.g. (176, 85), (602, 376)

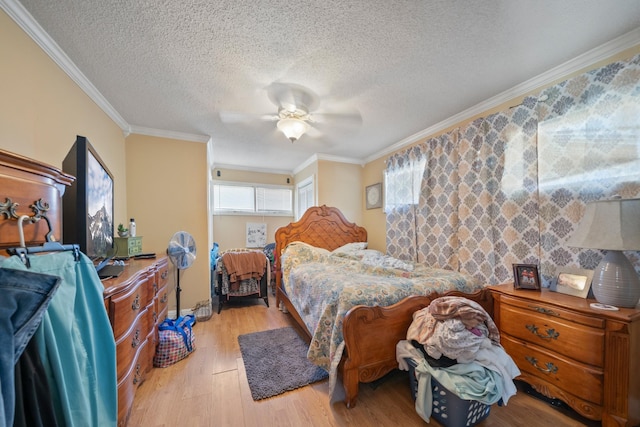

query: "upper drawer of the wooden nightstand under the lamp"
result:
(500, 304), (605, 367)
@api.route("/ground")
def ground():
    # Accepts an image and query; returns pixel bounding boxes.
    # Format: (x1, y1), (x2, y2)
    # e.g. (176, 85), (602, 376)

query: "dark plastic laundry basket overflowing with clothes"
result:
(405, 358), (491, 427)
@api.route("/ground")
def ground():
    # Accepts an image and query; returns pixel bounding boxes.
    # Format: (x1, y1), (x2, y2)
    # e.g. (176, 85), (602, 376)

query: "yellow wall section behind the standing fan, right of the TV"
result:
(127, 134), (210, 310)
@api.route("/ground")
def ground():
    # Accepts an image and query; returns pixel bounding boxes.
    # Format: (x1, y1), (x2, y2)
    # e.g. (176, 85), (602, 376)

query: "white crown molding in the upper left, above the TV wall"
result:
(0, 0), (129, 134)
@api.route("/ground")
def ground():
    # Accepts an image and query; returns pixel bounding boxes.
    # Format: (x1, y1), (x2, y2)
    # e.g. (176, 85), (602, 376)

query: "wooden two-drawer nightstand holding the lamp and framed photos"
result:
(490, 284), (640, 426)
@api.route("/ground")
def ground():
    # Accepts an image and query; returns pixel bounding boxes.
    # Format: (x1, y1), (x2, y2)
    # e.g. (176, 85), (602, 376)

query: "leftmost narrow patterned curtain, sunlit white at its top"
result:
(384, 146), (425, 261)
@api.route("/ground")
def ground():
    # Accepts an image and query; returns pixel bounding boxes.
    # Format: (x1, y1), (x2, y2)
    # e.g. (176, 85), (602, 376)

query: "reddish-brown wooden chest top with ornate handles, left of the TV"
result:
(0, 150), (75, 255)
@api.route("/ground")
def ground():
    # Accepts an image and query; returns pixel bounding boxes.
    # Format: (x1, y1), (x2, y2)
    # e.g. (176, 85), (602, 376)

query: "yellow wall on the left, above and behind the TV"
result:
(0, 10), (127, 237)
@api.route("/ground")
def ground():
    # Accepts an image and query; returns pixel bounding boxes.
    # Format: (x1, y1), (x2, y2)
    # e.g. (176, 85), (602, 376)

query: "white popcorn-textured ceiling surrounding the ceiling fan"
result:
(8, 0), (640, 171)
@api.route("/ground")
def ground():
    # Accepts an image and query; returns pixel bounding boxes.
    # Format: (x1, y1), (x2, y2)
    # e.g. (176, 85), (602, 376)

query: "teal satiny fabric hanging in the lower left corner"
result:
(3, 252), (118, 427)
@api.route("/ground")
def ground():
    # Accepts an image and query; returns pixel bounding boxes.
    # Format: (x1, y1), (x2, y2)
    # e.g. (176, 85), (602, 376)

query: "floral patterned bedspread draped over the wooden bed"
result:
(282, 242), (482, 394)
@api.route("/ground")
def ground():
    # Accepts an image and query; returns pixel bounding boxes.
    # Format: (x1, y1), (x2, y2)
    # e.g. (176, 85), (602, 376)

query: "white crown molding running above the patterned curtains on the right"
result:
(364, 28), (640, 164)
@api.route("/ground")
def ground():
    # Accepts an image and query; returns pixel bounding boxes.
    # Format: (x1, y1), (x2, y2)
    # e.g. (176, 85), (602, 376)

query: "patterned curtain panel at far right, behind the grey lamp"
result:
(538, 55), (640, 280)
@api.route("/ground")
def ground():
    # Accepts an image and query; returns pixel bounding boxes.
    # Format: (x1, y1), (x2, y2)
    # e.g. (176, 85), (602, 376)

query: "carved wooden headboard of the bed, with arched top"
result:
(273, 205), (367, 275)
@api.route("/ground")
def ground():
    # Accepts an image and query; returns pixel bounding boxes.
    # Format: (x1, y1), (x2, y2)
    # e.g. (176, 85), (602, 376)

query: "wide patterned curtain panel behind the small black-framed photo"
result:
(459, 98), (540, 284)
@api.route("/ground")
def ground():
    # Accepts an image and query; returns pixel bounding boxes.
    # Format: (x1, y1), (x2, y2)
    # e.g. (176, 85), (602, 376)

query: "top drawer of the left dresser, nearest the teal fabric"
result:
(109, 276), (153, 340)
